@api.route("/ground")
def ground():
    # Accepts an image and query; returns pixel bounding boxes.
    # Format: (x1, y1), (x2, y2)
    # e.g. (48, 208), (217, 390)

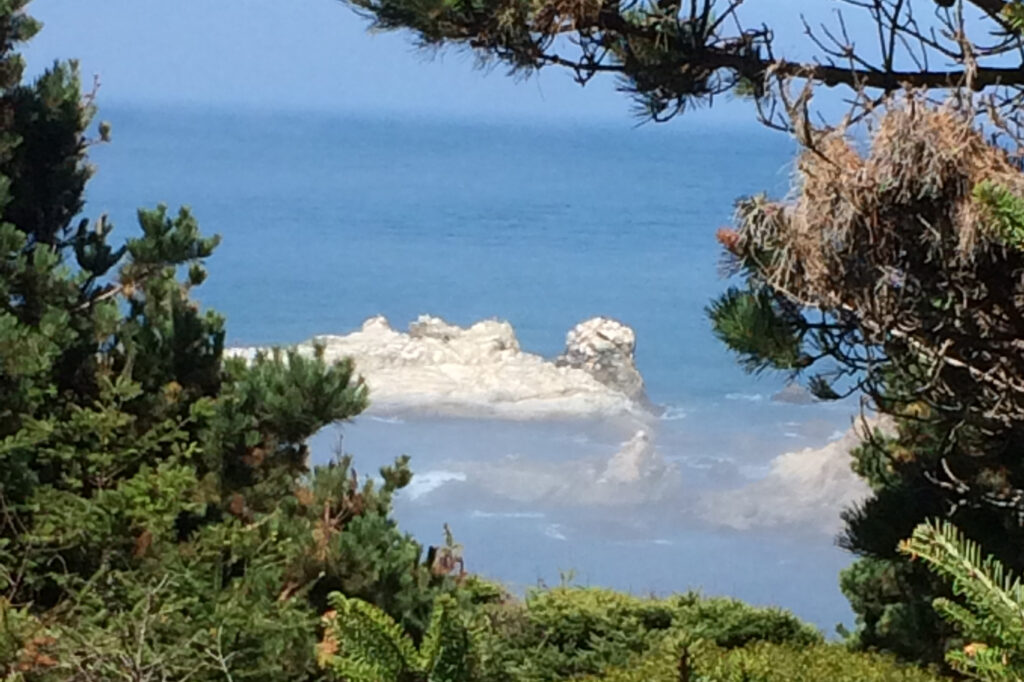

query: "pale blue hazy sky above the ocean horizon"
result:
(26, 0), (864, 121)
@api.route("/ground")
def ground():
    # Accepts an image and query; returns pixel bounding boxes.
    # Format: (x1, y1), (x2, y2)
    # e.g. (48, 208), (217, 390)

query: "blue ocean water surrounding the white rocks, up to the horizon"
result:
(87, 108), (850, 628)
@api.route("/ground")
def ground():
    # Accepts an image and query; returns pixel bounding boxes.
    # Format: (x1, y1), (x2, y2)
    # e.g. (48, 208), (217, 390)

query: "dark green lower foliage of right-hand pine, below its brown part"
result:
(840, 399), (1024, 663)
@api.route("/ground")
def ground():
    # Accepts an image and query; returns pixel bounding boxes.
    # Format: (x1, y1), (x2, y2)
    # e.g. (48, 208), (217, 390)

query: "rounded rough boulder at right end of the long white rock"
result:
(555, 317), (644, 400)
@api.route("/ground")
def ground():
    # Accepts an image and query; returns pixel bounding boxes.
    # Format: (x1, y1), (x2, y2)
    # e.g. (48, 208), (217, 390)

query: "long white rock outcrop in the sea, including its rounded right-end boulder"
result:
(226, 315), (648, 419)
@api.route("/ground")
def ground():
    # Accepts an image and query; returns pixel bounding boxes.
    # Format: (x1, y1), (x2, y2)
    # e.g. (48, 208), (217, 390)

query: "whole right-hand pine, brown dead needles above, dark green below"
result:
(710, 96), (1024, 662)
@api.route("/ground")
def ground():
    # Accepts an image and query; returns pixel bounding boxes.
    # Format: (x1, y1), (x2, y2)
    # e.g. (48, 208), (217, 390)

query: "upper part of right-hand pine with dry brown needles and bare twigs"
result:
(730, 95), (1024, 428)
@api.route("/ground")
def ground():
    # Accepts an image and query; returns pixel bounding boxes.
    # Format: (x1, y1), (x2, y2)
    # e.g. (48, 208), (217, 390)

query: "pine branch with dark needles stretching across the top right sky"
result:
(343, 0), (1024, 126)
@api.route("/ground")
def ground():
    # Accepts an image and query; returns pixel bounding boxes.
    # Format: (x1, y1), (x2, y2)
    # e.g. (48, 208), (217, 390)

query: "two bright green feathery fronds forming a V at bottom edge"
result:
(319, 592), (470, 682)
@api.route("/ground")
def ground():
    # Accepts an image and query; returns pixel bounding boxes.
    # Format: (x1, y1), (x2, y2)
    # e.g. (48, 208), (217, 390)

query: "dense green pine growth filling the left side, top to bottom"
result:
(0, 0), (460, 680)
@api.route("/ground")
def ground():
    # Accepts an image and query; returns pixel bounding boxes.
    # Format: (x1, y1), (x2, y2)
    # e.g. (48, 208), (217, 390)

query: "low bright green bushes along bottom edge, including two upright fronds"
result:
(321, 588), (944, 682)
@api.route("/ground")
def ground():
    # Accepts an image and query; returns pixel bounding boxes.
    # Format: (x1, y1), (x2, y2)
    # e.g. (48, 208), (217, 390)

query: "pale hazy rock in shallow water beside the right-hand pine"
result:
(699, 420), (889, 534)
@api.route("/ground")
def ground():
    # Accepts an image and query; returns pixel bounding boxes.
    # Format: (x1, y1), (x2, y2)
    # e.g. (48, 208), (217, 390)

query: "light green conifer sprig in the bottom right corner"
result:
(900, 522), (1024, 682)
